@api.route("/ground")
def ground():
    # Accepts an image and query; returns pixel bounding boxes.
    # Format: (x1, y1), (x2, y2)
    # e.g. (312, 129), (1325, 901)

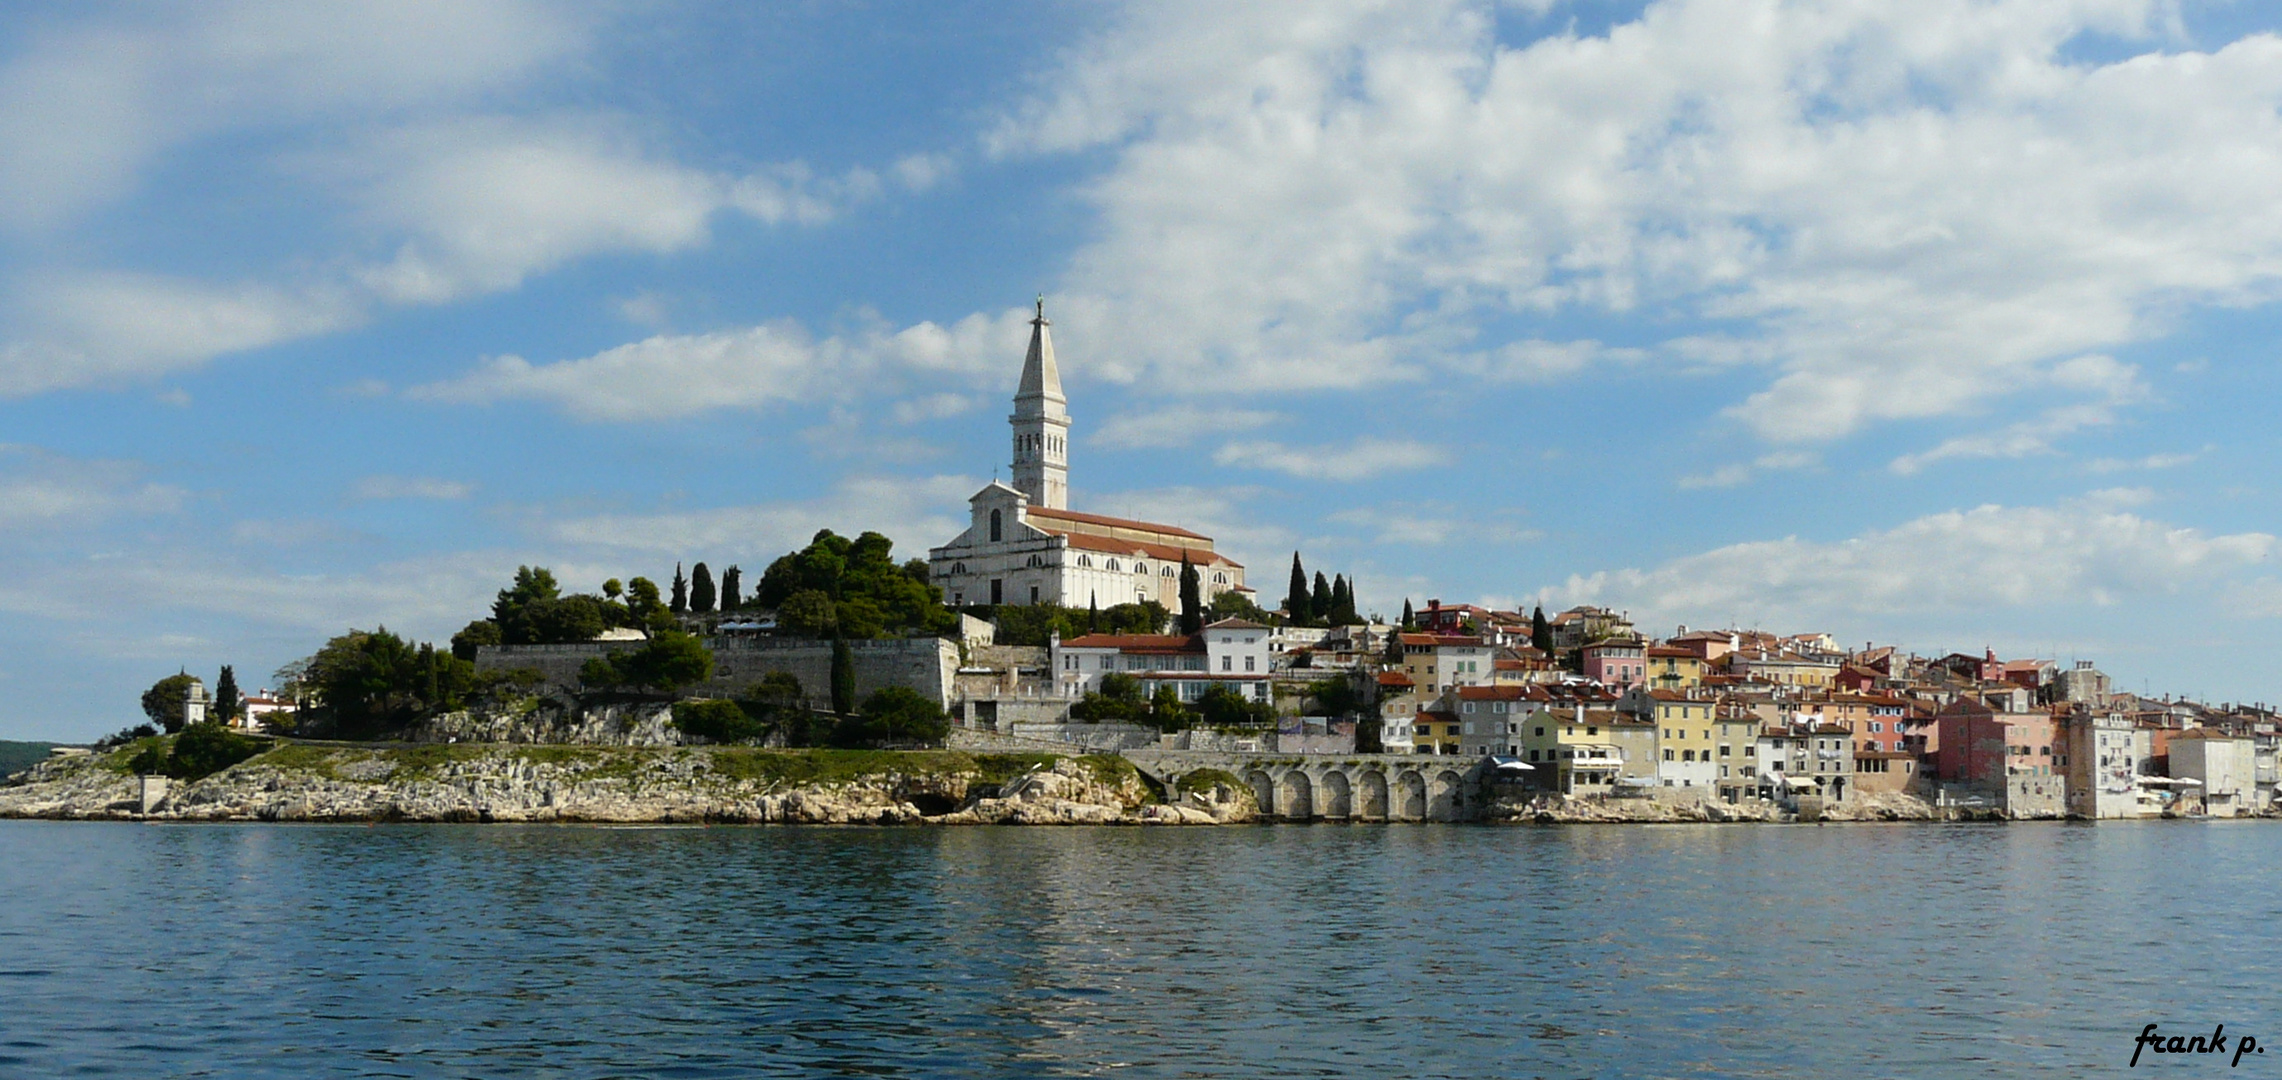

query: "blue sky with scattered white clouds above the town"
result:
(0, 0), (2282, 740)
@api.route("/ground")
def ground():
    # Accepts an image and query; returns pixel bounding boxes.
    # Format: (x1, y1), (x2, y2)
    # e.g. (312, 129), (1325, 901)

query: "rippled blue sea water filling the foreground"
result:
(0, 822), (2282, 1078)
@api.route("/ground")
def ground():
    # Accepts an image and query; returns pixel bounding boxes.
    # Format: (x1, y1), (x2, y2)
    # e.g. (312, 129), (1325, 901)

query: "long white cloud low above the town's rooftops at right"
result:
(1549, 489), (2275, 626)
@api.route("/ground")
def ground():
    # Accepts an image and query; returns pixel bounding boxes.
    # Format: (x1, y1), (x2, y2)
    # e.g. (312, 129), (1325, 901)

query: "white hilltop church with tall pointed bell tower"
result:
(926, 299), (1251, 612)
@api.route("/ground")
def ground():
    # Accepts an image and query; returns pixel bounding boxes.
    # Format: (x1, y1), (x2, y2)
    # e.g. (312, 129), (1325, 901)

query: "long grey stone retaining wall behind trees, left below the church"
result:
(475, 637), (958, 706)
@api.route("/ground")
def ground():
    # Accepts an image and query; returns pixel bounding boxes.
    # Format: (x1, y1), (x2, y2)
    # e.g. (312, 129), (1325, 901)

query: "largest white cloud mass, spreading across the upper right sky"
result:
(984, 0), (2282, 445)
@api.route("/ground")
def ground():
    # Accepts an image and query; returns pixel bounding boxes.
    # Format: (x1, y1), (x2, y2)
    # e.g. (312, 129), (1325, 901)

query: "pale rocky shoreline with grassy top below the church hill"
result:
(0, 744), (1257, 824)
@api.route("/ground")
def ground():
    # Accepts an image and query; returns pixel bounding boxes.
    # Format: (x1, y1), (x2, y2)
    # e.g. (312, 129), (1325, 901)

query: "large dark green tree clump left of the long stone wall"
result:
(304, 628), (477, 738)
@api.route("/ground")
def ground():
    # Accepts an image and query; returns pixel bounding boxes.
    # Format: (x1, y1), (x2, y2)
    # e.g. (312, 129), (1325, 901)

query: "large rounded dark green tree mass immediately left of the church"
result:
(753, 530), (958, 637)
